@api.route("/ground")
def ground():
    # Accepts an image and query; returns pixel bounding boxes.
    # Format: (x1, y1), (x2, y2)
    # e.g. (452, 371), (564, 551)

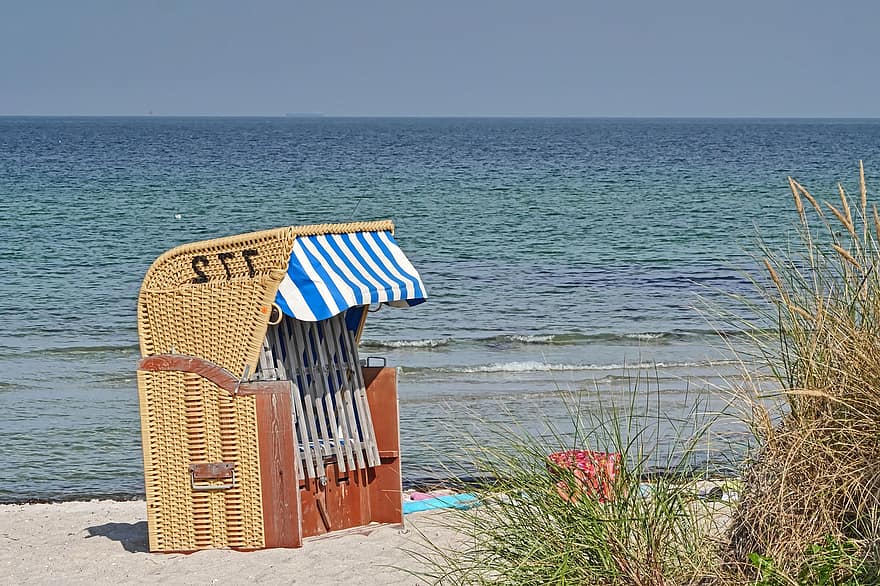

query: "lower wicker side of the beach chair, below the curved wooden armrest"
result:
(138, 372), (264, 551)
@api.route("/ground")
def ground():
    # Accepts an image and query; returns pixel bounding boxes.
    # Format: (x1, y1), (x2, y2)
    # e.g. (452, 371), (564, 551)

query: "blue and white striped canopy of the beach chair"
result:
(275, 231), (428, 321)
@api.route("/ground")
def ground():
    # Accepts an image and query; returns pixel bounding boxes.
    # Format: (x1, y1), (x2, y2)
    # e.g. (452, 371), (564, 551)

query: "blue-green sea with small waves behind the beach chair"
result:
(0, 117), (880, 502)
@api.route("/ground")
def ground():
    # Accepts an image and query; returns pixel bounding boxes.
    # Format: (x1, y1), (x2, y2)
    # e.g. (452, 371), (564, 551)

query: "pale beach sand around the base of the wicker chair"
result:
(0, 501), (457, 586)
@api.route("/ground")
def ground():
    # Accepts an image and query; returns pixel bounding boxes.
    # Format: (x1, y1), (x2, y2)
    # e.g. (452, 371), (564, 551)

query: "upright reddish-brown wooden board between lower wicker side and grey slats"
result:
(256, 382), (303, 547)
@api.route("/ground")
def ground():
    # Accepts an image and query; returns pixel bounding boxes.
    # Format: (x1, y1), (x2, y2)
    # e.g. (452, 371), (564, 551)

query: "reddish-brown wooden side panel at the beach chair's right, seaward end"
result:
(363, 367), (403, 523)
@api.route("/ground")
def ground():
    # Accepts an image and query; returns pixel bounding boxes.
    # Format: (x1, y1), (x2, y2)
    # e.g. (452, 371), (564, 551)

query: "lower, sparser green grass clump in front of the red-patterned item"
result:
(417, 374), (730, 584)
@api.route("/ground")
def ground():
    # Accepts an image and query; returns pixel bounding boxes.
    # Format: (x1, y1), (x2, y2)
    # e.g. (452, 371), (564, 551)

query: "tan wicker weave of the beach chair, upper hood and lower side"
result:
(138, 221), (393, 551)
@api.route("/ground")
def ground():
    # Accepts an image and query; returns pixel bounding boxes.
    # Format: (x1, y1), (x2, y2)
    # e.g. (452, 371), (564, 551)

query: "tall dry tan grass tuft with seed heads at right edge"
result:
(727, 164), (880, 584)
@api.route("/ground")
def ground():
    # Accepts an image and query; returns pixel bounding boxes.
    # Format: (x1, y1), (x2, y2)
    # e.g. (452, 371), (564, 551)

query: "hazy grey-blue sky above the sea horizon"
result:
(0, 0), (880, 116)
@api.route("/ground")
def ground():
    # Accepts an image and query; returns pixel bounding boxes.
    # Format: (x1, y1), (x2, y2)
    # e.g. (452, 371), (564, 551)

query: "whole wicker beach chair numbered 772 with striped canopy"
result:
(138, 221), (426, 552)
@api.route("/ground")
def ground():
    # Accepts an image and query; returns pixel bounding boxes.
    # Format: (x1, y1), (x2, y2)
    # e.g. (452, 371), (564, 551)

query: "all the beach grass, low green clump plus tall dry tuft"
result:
(418, 165), (880, 586)
